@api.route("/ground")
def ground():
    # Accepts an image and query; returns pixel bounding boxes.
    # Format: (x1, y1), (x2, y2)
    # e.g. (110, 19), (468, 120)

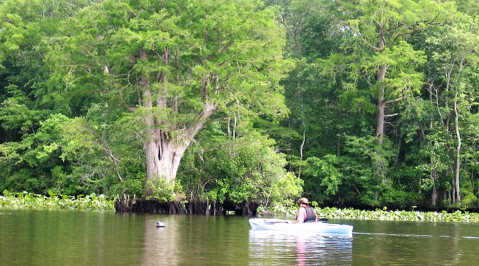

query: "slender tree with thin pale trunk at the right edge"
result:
(426, 11), (479, 204)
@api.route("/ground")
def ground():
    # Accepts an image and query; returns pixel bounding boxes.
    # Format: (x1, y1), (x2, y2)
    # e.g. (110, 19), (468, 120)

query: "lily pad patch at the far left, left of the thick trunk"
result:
(0, 190), (115, 211)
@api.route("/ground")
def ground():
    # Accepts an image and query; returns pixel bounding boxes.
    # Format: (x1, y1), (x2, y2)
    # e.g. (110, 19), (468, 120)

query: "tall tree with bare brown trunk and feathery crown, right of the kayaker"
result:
(331, 0), (453, 143)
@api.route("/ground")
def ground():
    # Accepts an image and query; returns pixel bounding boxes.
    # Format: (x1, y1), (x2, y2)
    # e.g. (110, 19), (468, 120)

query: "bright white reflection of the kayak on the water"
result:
(249, 230), (353, 266)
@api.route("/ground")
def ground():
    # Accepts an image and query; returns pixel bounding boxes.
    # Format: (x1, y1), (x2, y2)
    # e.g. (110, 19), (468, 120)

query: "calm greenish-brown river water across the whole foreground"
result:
(0, 209), (479, 266)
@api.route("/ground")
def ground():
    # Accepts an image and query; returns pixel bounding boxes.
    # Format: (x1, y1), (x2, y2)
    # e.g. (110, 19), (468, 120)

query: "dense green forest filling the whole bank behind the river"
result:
(0, 0), (479, 212)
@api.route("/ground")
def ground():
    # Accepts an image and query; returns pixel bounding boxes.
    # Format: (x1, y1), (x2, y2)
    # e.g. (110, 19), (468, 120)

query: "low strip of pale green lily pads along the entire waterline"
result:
(0, 191), (479, 223)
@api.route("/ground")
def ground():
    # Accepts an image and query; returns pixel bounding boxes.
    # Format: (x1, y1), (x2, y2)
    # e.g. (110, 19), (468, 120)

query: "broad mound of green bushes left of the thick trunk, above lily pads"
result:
(0, 109), (143, 195)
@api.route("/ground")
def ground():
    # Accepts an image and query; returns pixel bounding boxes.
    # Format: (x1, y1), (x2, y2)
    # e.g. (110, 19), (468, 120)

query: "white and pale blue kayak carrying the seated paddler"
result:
(249, 218), (353, 237)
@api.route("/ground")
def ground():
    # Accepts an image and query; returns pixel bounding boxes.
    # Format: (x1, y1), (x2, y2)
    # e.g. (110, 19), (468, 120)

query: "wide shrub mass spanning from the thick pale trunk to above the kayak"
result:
(179, 121), (303, 206)
